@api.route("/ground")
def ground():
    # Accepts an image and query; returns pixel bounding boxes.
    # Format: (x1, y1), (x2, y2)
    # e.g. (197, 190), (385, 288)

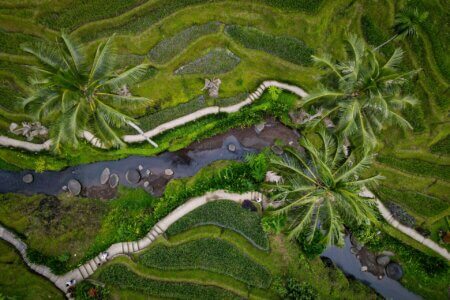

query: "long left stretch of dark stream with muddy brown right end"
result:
(0, 119), (298, 198)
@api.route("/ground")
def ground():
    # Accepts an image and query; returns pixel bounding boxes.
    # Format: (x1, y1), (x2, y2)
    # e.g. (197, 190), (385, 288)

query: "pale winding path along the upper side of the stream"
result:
(0, 81), (308, 152)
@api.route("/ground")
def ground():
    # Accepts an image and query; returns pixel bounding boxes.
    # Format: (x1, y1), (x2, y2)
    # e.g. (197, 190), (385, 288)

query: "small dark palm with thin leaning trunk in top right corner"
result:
(374, 8), (428, 51)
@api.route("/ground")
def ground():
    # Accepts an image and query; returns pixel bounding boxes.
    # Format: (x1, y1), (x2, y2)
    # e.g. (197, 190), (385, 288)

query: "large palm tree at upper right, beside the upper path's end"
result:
(301, 35), (417, 149)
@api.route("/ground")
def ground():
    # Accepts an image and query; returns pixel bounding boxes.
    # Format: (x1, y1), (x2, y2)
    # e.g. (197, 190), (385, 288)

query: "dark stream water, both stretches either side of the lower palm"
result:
(0, 120), (421, 300)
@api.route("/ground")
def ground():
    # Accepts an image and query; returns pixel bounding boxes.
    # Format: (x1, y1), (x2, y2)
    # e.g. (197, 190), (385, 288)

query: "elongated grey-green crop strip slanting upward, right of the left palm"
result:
(148, 22), (220, 64)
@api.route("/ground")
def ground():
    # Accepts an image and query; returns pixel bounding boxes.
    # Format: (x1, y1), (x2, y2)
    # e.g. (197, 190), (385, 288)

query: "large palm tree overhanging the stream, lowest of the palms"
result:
(269, 130), (382, 245)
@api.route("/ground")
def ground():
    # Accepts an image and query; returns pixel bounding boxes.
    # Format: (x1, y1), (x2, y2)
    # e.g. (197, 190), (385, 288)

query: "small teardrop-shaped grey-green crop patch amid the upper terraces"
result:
(175, 48), (241, 75)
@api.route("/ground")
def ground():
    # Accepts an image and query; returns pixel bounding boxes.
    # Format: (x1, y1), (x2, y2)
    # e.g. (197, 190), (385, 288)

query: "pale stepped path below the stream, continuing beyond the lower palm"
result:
(0, 189), (450, 297)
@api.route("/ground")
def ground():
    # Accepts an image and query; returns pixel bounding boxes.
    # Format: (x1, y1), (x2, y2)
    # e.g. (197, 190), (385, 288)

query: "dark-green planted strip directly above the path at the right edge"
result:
(376, 185), (448, 217)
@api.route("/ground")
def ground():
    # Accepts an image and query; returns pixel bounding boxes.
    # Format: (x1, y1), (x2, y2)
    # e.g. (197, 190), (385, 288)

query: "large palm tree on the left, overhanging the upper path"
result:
(22, 33), (155, 152)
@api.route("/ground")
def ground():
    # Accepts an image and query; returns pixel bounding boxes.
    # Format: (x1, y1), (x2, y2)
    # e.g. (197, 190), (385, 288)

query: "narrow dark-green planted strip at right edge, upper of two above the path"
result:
(377, 155), (450, 181)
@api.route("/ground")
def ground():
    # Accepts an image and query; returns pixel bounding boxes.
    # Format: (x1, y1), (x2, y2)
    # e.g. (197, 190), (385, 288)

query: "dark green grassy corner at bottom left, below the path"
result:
(0, 241), (64, 300)
